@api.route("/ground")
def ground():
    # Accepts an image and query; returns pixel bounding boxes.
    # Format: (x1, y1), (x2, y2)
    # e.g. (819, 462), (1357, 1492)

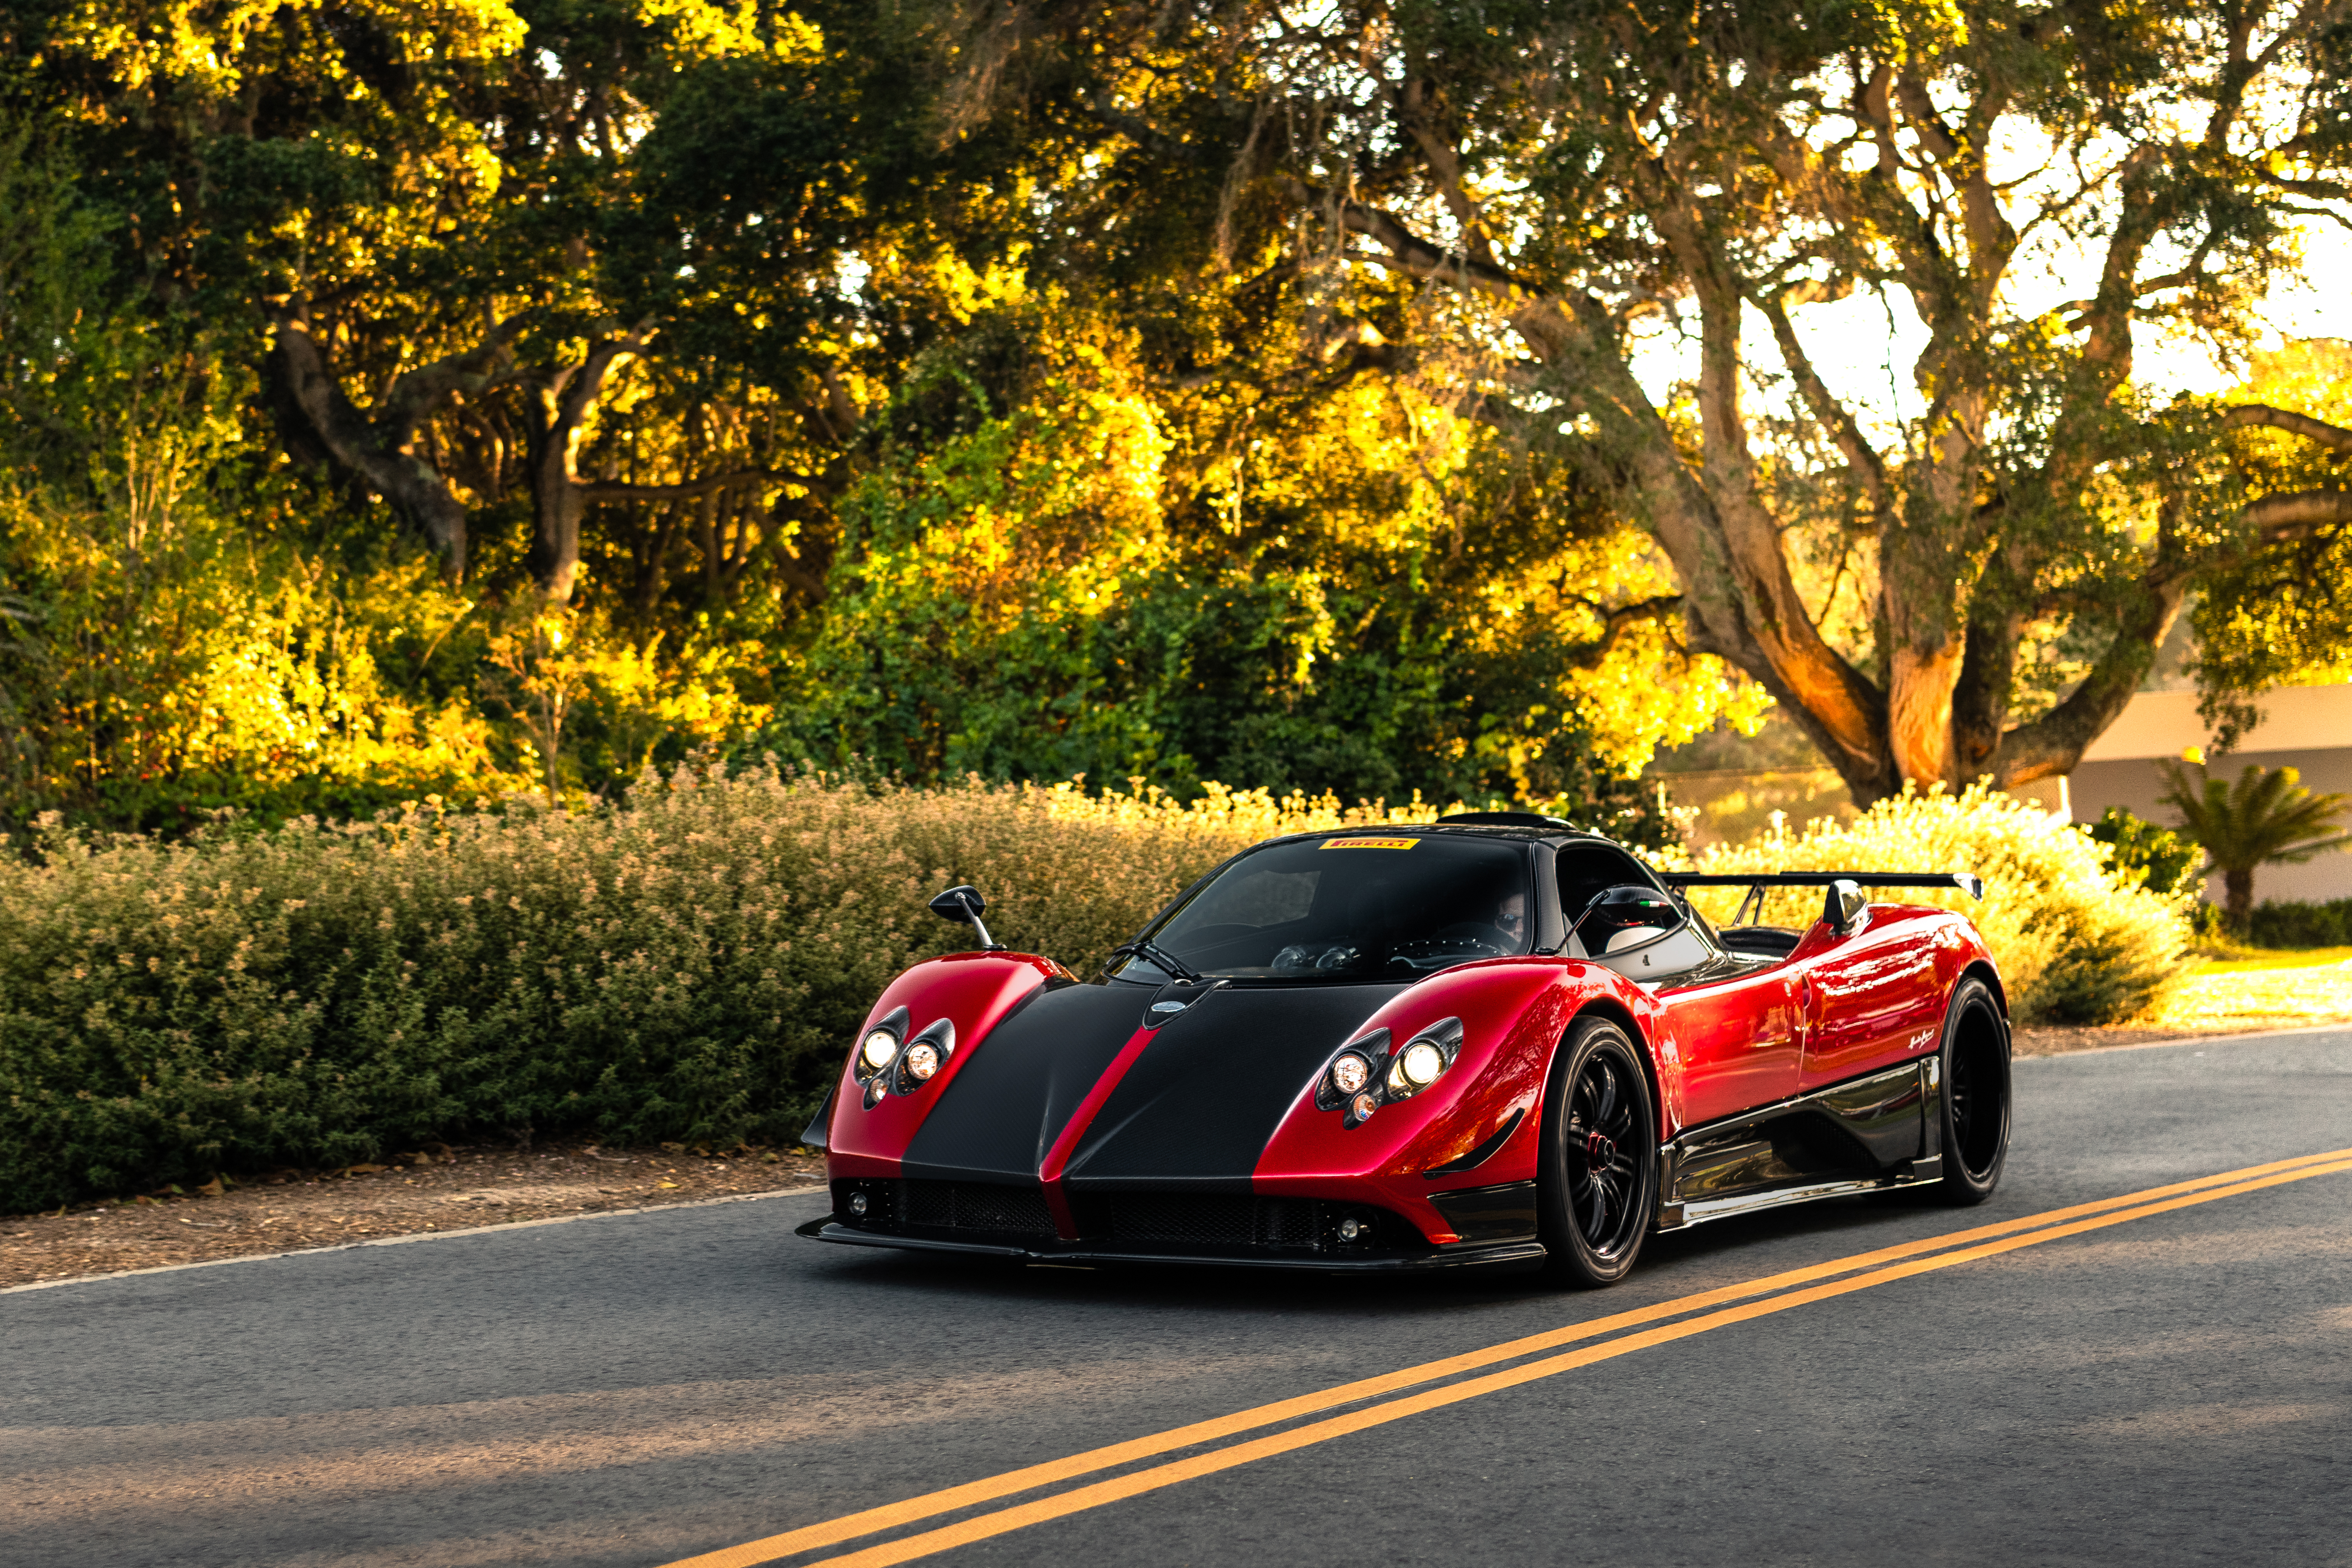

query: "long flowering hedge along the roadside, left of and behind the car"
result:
(0, 764), (1432, 1211)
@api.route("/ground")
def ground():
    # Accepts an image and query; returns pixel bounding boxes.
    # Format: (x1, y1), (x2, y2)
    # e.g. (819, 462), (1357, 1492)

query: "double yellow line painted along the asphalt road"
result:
(668, 1150), (2352, 1568)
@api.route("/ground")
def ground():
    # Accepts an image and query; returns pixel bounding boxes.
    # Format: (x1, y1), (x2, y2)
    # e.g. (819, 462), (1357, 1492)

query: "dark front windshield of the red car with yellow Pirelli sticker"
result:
(1117, 835), (1534, 980)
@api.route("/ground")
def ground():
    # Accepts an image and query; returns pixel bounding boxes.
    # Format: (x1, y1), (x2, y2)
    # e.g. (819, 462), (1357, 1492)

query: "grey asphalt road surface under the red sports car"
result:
(0, 1032), (2352, 1568)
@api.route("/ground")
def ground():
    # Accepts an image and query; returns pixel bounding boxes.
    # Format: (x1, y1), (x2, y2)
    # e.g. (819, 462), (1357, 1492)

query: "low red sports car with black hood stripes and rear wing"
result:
(802, 813), (2009, 1284)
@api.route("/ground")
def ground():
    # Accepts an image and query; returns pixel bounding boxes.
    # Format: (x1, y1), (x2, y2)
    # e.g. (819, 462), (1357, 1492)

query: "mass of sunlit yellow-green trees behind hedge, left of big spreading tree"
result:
(0, 0), (1764, 837)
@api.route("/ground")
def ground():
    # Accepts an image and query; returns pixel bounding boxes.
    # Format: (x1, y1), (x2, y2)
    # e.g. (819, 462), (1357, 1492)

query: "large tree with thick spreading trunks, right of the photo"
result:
(957, 0), (2352, 804)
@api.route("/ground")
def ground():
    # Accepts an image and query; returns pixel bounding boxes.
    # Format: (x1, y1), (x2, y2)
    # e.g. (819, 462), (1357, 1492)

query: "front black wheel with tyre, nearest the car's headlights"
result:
(1538, 1018), (1658, 1286)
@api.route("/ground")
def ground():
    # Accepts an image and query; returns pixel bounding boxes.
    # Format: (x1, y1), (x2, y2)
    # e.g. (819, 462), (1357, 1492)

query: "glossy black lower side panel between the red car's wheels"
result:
(1656, 1056), (1943, 1229)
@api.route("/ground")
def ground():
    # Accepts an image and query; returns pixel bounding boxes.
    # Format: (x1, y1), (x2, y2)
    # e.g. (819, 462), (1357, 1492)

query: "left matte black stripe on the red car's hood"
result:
(903, 985), (1152, 1182)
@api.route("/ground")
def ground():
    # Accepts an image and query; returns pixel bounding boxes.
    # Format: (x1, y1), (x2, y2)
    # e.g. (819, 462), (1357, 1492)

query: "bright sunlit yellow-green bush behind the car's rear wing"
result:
(1698, 785), (2190, 1023)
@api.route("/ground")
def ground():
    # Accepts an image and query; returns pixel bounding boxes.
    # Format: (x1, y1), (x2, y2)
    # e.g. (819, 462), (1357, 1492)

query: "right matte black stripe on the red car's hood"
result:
(1070, 985), (1404, 1192)
